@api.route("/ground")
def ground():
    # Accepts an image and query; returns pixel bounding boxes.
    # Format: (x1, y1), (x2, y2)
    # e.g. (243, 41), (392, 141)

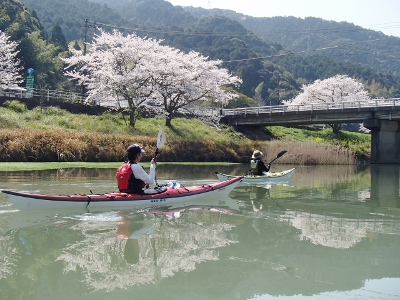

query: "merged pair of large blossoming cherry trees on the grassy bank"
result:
(64, 30), (240, 127)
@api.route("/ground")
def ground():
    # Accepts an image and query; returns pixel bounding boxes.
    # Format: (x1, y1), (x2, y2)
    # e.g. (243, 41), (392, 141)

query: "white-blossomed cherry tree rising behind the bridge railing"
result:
(284, 75), (370, 134)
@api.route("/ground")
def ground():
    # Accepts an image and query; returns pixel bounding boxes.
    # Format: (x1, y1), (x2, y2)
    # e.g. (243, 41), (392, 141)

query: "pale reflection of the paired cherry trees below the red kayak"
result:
(57, 212), (237, 291)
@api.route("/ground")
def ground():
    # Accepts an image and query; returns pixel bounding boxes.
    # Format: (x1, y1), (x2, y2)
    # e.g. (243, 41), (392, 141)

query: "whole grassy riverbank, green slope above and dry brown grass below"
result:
(0, 101), (370, 164)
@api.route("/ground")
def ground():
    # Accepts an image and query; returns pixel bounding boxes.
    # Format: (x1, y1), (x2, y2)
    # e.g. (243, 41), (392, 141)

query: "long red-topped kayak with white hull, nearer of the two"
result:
(2, 176), (243, 210)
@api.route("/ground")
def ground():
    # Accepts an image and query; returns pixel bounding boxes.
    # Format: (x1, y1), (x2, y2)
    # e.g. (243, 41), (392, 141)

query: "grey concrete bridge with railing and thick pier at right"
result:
(220, 98), (400, 164)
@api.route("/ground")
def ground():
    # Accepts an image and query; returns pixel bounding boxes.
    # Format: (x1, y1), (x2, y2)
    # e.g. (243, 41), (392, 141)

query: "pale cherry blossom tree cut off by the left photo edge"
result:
(0, 30), (22, 88)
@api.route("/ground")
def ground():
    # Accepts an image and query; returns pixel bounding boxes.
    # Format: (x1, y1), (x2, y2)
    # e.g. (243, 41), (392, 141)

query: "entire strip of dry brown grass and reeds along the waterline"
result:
(0, 129), (355, 165)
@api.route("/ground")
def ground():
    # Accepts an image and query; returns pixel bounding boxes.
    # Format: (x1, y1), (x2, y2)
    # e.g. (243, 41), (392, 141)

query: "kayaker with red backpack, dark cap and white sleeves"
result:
(116, 144), (156, 194)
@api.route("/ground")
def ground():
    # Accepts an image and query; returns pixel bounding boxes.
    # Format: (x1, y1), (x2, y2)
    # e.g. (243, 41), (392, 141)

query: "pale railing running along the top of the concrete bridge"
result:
(222, 98), (400, 116)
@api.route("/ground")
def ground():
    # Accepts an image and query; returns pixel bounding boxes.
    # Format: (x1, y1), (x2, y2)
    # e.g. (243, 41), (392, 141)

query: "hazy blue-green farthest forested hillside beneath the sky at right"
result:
(185, 7), (400, 76)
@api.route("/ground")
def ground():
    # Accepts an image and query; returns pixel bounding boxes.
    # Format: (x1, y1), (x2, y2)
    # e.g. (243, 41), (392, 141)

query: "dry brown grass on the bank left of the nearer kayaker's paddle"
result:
(0, 129), (148, 162)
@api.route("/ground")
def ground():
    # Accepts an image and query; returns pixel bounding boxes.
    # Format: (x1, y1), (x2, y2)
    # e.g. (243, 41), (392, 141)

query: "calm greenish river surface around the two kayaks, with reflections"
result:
(0, 164), (400, 300)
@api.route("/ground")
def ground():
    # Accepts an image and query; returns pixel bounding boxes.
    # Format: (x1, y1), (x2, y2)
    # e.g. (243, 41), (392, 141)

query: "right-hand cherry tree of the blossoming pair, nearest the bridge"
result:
(153, 48), (241, 127)
